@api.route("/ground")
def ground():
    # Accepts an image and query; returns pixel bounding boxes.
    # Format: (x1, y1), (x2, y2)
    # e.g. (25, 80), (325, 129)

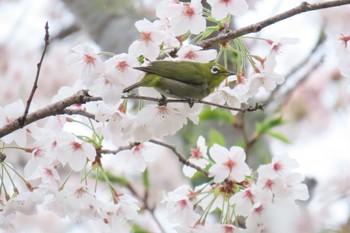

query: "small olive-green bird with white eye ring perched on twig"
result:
(123, 60), (235, 104)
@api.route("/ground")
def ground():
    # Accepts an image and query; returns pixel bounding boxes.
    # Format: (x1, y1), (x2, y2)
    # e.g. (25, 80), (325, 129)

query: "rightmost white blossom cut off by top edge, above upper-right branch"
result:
(208, 0), (248, 20)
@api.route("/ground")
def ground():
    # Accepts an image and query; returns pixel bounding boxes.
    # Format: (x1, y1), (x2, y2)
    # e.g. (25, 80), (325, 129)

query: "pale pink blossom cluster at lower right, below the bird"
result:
(165, 137), (309, 233)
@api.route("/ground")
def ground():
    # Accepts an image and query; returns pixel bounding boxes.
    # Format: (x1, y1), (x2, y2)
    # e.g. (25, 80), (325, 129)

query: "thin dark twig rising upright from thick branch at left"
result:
(19, 22), (50, 127)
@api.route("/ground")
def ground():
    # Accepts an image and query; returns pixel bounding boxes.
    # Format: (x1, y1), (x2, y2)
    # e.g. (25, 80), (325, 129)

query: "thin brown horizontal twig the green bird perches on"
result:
(122, 95), (265, 112)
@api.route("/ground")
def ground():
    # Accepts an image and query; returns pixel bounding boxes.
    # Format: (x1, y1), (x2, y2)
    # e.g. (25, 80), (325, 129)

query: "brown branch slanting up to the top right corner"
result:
(199, 0), (350, 48)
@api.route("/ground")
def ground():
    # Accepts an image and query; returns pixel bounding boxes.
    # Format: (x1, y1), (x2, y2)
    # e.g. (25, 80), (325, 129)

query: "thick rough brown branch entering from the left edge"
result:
(0, 90), (102, 138)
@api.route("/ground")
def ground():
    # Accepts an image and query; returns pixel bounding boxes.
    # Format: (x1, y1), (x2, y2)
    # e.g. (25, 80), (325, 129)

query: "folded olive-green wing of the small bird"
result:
(134, 61), (203, 85)
